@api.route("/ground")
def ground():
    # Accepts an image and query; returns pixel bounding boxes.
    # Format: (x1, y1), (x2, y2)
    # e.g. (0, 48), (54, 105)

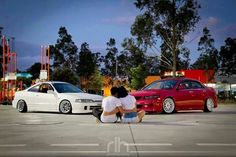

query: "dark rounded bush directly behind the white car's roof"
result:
(52, 68), (79, 85)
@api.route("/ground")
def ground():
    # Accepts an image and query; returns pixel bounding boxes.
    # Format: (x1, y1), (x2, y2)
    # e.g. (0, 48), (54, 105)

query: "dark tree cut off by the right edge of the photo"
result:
(219, 38), (236, 76)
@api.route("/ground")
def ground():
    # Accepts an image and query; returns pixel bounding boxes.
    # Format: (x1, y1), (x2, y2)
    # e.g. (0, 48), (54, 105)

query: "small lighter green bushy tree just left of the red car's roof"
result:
(130, 65), (147, 90)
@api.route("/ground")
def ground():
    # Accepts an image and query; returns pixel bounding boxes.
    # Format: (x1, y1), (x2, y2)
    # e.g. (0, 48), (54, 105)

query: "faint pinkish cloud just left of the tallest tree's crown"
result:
(102, 16), (135, 25)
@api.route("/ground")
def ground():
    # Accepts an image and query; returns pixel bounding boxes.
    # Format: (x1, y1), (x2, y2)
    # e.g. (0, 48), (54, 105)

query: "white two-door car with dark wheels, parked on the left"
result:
(12, 82), (103, 114)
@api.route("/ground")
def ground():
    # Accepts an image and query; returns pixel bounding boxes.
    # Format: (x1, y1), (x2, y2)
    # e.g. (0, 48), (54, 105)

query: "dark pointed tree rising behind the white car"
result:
(51, 27), (78, 72)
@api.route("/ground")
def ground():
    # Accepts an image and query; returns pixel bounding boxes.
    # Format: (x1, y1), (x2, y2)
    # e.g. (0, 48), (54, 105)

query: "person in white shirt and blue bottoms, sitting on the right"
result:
(119, 86), (145, 123)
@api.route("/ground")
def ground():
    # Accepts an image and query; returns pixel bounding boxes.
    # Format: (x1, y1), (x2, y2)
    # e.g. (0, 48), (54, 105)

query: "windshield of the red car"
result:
(143, 80), (177, 90)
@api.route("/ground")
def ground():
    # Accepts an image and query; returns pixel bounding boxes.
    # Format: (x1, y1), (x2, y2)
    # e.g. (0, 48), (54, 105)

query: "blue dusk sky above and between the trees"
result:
(0, 0), (236, 70)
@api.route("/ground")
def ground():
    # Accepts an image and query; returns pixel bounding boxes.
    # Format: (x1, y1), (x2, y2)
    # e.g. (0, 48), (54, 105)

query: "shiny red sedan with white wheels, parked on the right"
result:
(130, 78), (217, 113)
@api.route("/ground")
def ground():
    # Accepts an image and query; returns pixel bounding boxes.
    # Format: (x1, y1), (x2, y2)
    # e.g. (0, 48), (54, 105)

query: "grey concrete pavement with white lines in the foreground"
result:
(0, 104), (236, 157)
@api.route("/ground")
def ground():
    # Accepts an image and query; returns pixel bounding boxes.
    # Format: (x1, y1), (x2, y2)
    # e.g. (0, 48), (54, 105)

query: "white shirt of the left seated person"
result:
(101, 96), (121, 123)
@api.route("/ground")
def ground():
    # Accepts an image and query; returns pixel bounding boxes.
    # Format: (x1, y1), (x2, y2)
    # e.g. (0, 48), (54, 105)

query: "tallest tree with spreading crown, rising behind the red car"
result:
(131, 0), (200, 76)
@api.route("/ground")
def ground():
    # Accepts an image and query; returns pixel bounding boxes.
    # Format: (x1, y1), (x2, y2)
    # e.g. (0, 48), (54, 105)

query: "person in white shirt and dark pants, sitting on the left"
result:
(92, 87), (134, 123)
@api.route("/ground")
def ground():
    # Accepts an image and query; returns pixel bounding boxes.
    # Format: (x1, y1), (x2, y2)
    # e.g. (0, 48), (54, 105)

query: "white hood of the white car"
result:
(59, 93), (103, 101)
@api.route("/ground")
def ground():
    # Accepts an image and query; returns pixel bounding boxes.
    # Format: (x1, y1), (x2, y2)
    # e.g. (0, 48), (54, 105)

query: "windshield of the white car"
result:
(53, 83), (83, 93)
